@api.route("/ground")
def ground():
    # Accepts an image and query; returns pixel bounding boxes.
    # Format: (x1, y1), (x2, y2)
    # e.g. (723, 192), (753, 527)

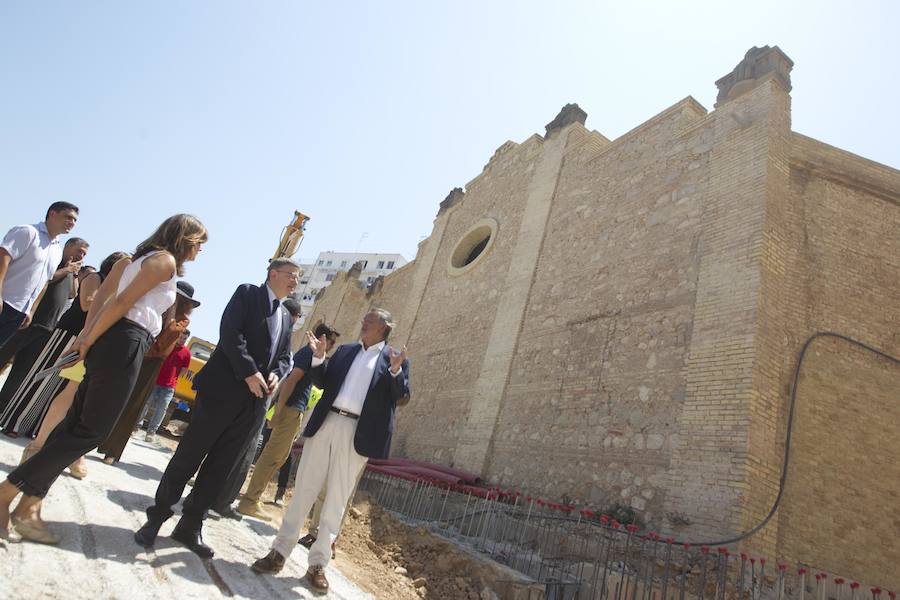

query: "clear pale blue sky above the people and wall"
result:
(0, 0), (900, 340)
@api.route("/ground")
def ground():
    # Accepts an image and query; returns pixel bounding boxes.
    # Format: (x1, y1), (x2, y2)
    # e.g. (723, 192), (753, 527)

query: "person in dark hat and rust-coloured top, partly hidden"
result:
(97, 280), (200, 465)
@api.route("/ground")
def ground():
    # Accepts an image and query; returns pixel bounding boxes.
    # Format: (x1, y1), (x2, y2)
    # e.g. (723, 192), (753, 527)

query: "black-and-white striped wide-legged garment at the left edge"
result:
(0, 329), (75, 436)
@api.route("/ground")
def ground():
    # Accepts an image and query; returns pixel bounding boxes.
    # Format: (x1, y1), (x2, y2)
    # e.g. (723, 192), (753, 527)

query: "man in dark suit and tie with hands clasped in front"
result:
(134, 259), (300, 558)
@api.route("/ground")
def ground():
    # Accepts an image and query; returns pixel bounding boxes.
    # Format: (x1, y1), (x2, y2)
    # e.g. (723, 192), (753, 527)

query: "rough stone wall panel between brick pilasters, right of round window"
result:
(487, 99), (710, 520)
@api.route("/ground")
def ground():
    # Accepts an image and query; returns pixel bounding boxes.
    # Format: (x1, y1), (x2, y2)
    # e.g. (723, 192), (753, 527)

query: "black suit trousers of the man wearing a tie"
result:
(147, 382), (266, 529)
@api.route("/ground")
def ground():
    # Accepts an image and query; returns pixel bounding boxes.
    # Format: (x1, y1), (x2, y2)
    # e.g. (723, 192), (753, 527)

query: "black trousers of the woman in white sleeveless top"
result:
(8, 319), (151, 498)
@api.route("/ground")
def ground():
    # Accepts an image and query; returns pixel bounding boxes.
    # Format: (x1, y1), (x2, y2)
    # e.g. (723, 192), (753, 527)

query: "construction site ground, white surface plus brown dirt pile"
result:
(0, 422), (509, 600)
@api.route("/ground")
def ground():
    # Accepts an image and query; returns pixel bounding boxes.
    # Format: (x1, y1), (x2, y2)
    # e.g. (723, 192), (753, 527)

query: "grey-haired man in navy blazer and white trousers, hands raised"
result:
(253, 308), (409, 591)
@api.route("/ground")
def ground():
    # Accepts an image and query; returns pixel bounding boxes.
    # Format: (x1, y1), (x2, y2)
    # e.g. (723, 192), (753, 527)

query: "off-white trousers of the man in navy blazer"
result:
(272, 412), (368, 567)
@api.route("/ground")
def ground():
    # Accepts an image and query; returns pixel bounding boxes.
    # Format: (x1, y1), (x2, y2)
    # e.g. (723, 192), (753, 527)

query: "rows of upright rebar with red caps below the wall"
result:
(360, 471), (896, 600)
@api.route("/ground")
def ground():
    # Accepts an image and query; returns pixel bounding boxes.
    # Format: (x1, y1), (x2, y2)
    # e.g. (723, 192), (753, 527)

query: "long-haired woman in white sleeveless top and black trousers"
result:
(0, 215), (207, 544)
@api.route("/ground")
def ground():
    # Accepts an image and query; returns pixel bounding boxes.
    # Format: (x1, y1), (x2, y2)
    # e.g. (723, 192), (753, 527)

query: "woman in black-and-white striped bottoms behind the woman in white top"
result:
(0, 252), (127, 436)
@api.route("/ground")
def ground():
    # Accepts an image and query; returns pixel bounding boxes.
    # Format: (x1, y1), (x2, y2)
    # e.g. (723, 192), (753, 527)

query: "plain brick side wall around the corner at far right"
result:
(771, 144), (900, 587)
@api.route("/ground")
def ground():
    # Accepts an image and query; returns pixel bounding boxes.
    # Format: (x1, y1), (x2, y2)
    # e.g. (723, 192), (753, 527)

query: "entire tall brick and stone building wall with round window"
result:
(310, 49), (900, 583)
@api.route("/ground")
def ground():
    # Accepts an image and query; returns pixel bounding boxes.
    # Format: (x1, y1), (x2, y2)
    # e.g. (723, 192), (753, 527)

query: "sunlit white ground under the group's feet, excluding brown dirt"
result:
(0, 420), (372, 600)
